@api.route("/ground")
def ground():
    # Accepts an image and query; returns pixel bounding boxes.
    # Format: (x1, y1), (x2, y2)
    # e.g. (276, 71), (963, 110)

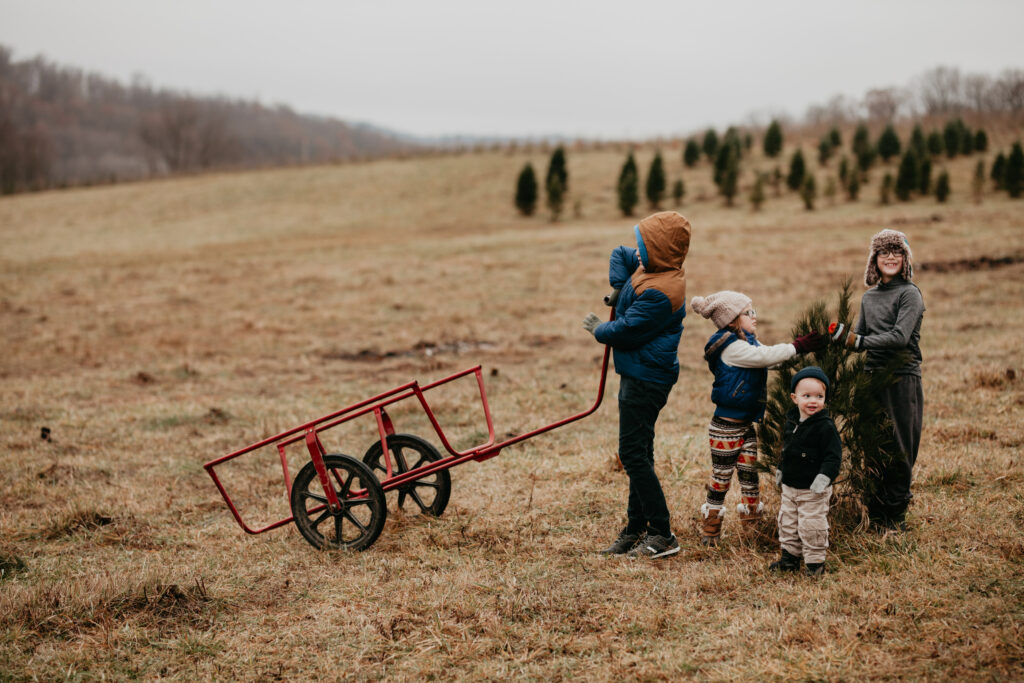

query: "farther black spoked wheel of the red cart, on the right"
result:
(362, 434), (452, 517)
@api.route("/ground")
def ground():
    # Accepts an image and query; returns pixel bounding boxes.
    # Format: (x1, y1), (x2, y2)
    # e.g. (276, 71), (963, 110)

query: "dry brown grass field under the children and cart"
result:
(0, 137), (1024, 681)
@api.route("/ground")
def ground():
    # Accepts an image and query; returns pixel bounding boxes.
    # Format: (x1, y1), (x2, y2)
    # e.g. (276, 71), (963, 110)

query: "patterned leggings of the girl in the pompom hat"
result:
(708, 418), (761, 510)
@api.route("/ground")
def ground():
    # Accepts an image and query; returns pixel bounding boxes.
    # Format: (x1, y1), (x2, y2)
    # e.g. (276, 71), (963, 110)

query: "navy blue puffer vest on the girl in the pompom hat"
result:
(705, 328), (768, 422)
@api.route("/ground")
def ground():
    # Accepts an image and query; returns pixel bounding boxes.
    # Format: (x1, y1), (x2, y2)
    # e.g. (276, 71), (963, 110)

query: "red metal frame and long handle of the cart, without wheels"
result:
(203, 311), (614, 533)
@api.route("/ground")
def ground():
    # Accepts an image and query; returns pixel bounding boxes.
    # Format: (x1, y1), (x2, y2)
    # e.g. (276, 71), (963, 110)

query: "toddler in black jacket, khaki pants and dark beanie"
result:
(768, 366), (843, 577)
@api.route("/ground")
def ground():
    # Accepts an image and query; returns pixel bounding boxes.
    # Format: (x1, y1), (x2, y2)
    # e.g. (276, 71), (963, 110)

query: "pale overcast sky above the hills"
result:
(0, 0), (1024, 139)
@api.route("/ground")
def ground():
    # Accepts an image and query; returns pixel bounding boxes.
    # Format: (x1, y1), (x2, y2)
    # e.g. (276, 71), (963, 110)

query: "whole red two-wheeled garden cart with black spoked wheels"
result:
(204, 309), (614, 550)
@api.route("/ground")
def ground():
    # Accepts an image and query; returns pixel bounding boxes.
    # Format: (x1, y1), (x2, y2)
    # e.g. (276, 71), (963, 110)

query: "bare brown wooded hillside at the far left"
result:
(0, 45), (417, 194)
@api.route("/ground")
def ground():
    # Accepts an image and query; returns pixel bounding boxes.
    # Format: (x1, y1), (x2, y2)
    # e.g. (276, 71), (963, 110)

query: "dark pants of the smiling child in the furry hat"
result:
(867, 375), (925, 522)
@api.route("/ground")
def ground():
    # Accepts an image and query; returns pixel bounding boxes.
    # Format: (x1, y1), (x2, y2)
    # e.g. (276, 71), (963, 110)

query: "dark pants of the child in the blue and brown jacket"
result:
(618, 376), (672, 536)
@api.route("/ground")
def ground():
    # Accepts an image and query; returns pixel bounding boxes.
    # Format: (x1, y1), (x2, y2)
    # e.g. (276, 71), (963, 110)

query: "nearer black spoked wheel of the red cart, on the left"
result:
(291, 455), (387, 550)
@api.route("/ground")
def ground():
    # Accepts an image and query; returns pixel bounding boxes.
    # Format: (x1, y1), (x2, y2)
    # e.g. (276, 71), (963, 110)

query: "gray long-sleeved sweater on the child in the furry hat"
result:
(853, 278), (925, 377)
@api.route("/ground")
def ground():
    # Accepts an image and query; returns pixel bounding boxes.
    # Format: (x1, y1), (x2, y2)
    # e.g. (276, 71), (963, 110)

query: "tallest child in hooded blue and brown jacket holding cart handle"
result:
(584, 211), (690, 558)
